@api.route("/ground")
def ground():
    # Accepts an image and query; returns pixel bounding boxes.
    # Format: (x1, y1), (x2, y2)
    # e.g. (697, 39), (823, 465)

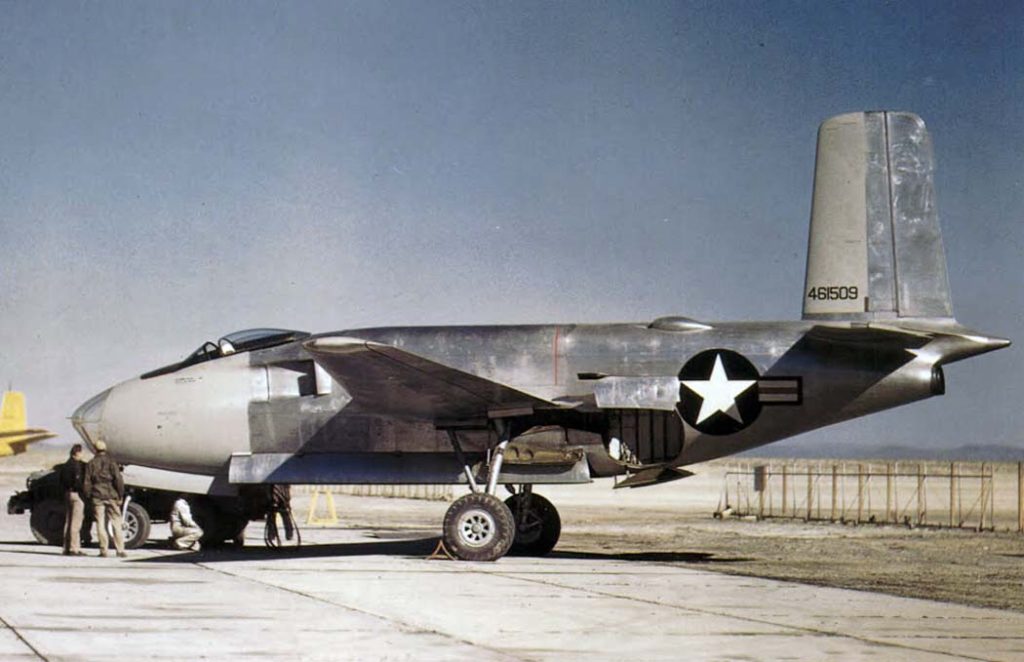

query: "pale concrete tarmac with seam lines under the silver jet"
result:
(0, 524), (1024, 660)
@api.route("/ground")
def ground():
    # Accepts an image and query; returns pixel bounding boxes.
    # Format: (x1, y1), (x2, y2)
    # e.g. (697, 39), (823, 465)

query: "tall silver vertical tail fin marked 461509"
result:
(804, 112), (952, 320)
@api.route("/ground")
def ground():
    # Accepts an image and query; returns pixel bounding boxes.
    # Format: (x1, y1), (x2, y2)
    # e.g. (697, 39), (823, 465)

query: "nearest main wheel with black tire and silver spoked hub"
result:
(442, 493), (515, 562)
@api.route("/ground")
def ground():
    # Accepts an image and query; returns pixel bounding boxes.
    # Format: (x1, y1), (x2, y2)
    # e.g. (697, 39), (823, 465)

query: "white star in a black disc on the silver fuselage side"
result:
(678, 349), (761, 435)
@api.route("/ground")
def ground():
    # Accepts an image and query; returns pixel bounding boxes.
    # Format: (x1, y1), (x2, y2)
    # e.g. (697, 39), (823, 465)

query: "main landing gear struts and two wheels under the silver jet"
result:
(441, 430), (562, 561)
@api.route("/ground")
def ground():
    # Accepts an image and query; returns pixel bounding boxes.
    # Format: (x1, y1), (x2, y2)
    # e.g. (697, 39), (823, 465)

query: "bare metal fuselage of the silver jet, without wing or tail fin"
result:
(75, 322), (966, 482)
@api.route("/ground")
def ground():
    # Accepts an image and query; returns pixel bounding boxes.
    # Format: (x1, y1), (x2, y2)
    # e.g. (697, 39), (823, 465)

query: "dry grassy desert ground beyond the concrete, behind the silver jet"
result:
(0, 450), (1024, 612)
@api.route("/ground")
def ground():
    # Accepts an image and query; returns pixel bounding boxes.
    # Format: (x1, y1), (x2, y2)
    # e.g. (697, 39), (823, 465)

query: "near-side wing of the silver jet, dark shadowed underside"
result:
(304, 336), (561, 420)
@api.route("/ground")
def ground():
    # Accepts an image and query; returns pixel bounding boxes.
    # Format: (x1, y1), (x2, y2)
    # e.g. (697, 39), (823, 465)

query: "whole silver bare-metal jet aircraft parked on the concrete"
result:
(73, 112), (1010, 561)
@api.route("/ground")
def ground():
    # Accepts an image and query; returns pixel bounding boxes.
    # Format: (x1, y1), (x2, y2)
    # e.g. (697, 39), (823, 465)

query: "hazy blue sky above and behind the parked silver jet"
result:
(0, 1), (1024, 450)
